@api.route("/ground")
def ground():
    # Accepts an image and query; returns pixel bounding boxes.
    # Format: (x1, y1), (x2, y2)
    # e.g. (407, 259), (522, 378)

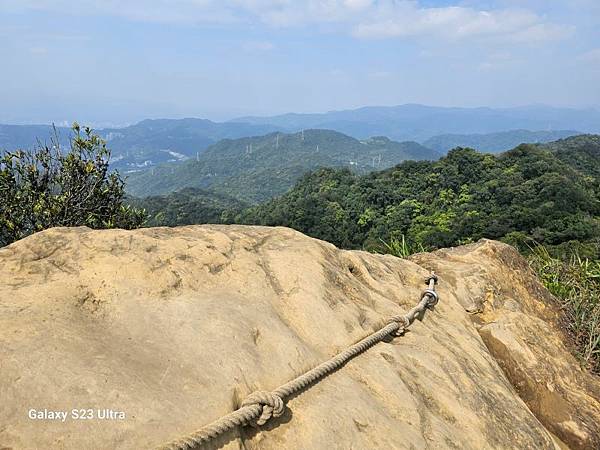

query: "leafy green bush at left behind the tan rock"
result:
(0, 124), (145, 246)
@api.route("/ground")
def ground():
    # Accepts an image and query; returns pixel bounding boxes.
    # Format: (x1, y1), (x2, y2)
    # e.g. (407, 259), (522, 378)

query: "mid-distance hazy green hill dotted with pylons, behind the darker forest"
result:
(127, 130), (440, 203)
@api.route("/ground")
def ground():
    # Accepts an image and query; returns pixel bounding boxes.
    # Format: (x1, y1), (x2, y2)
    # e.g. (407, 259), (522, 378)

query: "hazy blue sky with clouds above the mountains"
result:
(0, 0), (600, 125)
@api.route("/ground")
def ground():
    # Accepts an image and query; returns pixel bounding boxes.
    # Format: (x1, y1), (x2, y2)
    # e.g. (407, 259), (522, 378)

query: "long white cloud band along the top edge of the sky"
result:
(0, 0), (572, 42)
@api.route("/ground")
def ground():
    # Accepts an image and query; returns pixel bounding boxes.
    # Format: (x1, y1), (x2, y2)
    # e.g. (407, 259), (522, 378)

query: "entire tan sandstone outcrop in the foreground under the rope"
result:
(0, 226), (600, 449)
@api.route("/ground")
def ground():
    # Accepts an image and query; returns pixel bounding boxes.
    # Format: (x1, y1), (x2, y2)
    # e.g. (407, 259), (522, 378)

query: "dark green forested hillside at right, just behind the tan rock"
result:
(237, 136), (600, 253)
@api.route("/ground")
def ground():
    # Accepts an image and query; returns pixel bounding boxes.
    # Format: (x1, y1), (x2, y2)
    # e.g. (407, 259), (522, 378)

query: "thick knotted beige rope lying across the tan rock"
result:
(158, 272), (439, 450)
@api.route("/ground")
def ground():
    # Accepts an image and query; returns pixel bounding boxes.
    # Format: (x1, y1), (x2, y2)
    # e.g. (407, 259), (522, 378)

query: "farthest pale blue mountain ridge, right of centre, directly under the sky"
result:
(235, 104), (600, 143)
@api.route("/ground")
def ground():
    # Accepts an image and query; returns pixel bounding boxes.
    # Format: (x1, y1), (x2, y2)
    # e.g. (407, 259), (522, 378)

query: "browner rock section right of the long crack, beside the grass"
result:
(412, 241), (600, 449)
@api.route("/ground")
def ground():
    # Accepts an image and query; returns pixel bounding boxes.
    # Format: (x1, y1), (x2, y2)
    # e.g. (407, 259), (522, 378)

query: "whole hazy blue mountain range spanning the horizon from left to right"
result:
(0, 105), (600, 173)
